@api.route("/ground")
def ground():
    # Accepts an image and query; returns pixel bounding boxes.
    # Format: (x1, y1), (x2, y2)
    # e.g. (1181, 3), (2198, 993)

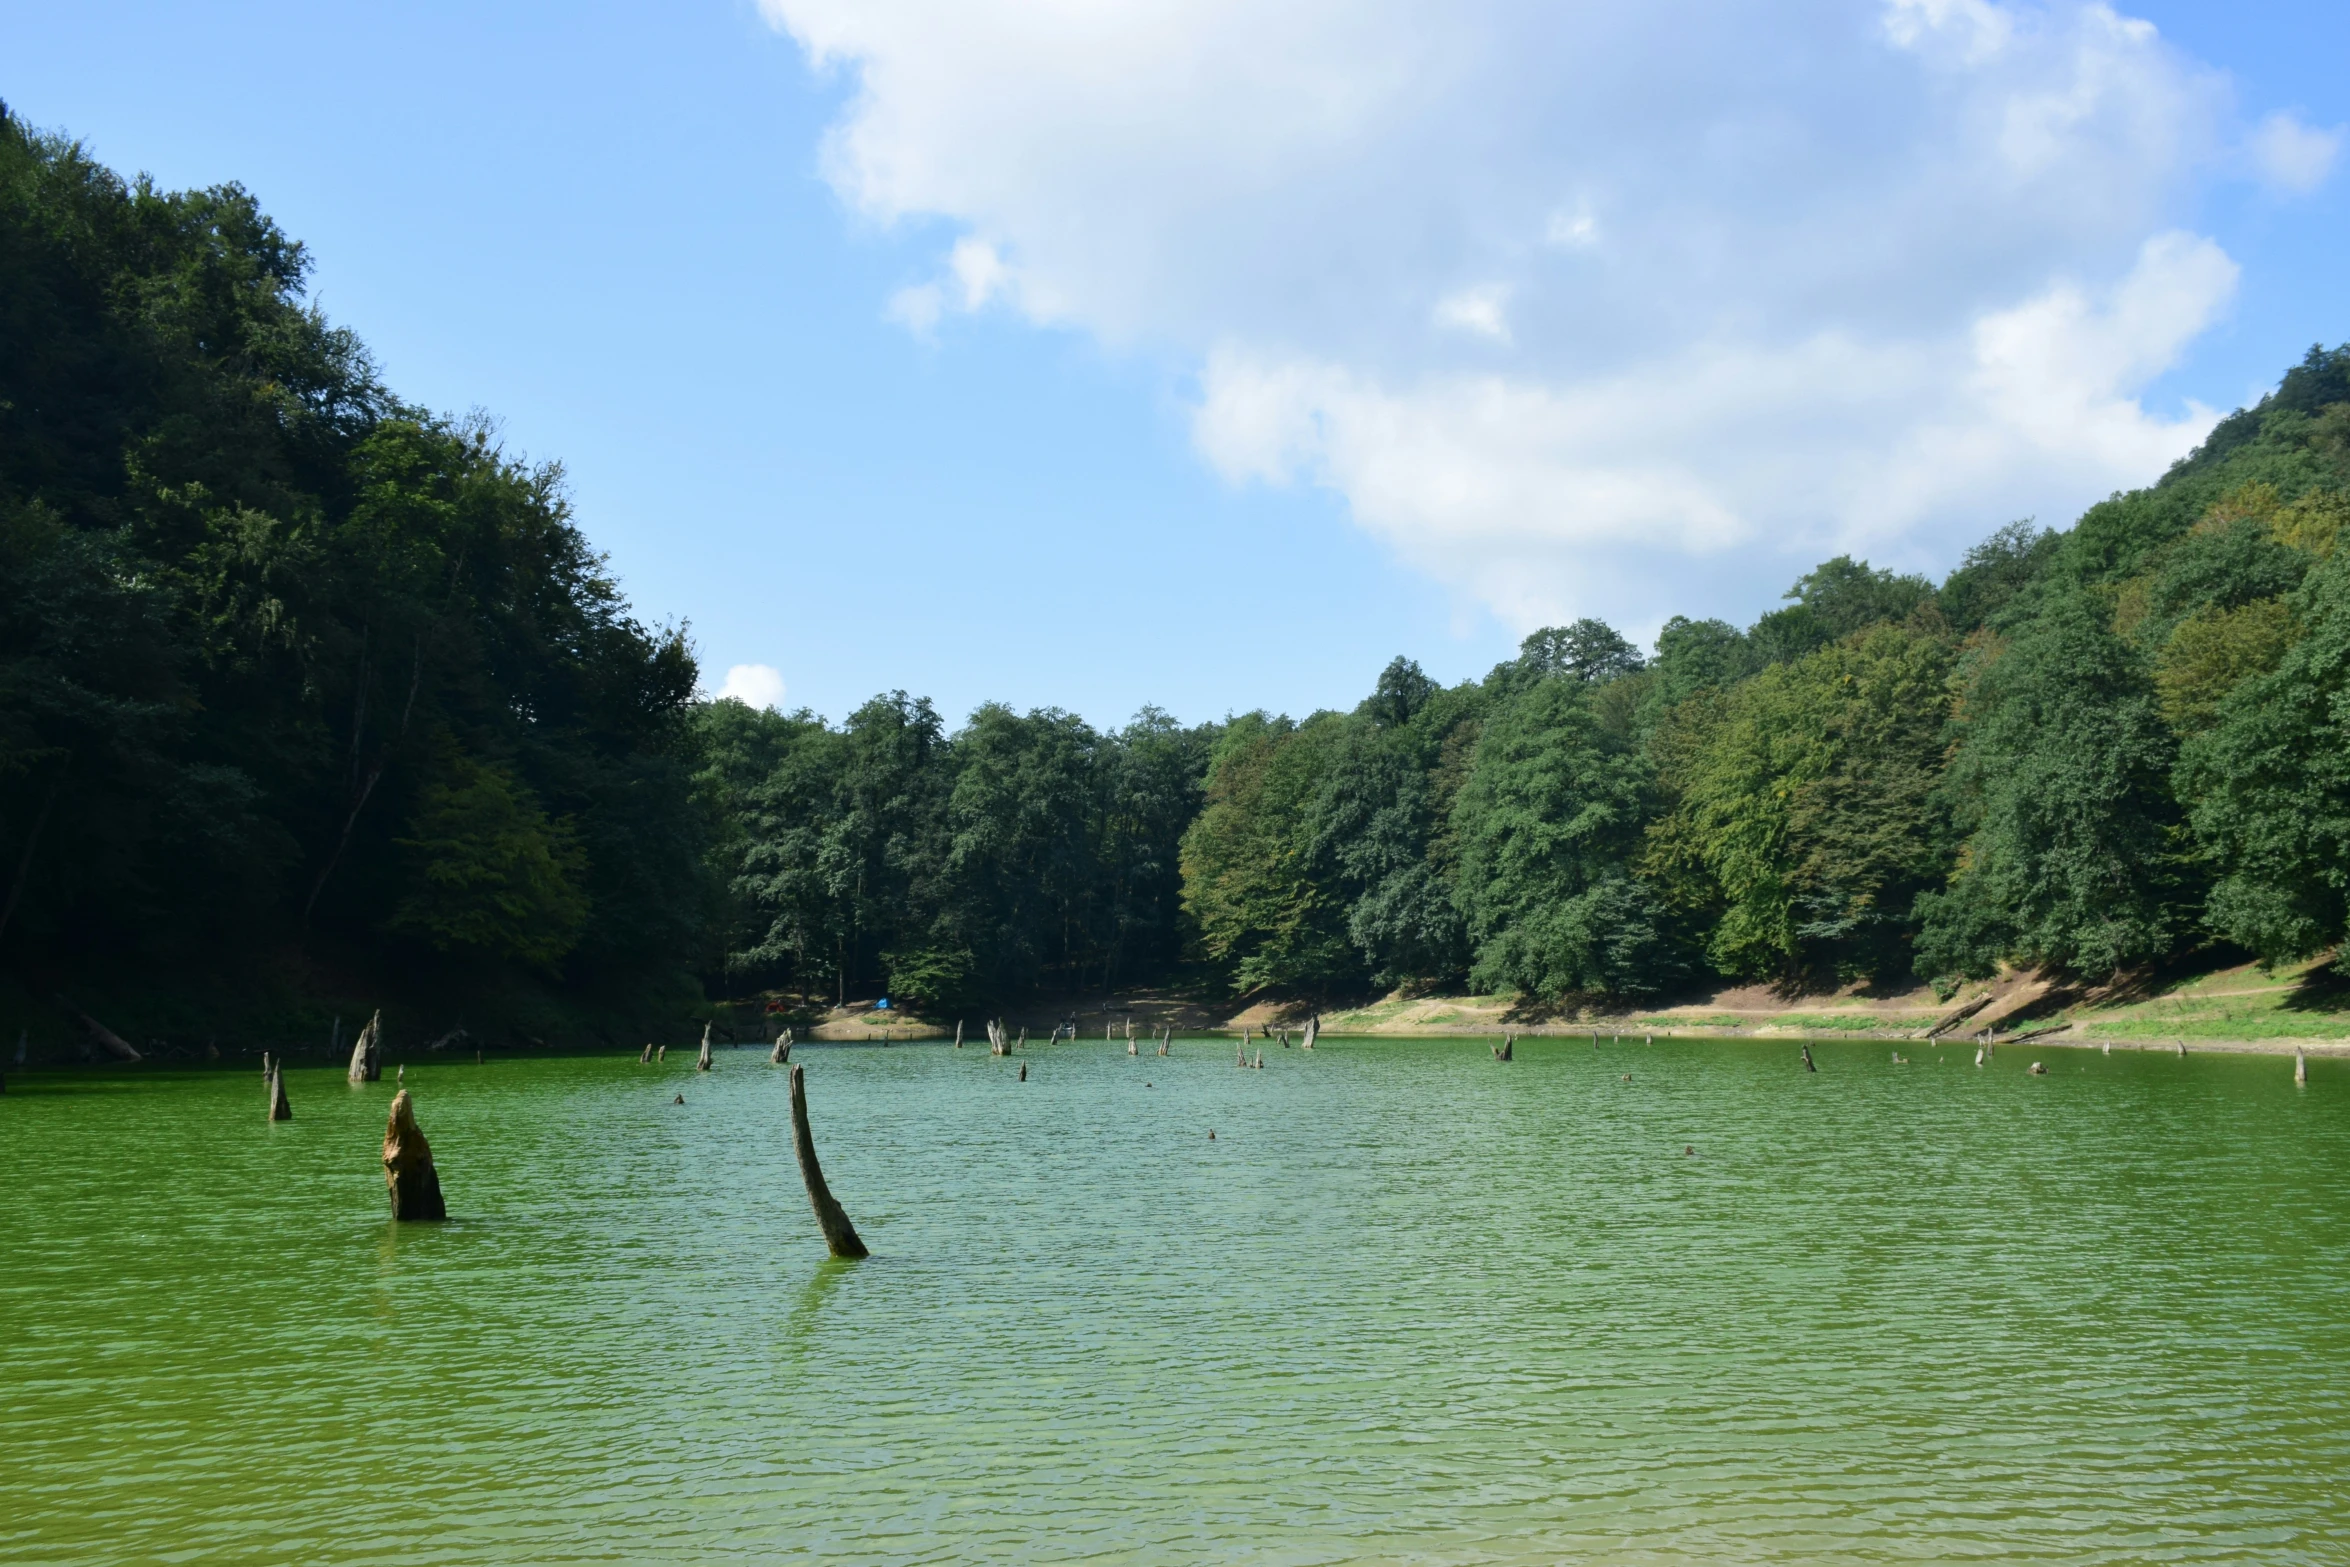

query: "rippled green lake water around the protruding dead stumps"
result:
(0, 1038), (2350, 1567)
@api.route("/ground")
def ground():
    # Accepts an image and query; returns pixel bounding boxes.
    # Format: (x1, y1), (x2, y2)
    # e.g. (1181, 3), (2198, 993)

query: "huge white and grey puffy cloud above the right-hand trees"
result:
(761, 0), (2293, 625)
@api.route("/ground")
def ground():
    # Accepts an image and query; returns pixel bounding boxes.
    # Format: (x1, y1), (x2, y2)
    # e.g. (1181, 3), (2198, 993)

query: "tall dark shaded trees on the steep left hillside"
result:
(0, 103), (717, 1022)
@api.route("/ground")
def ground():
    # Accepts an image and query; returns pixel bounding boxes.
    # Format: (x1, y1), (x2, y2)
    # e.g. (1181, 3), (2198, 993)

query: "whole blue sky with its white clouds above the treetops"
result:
(0, 0), (2350, 724)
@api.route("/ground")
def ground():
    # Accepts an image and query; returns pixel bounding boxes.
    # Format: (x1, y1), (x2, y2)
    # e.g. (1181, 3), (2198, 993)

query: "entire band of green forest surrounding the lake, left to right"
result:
(0, 110), (2350, 1041)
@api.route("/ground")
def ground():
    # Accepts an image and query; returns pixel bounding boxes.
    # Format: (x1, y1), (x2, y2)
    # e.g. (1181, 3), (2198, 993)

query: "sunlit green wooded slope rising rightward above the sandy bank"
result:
(1184, 350), (2350, 1003)
